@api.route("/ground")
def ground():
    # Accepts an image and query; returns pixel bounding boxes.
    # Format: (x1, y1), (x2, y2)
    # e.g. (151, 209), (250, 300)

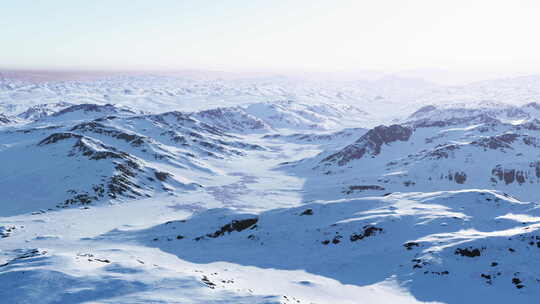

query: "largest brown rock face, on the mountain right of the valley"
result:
(321, 125), (413, 166)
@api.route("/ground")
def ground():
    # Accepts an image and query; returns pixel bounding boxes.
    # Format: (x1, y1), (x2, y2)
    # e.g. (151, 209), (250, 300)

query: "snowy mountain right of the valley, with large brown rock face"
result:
(284, 112), (540, 200)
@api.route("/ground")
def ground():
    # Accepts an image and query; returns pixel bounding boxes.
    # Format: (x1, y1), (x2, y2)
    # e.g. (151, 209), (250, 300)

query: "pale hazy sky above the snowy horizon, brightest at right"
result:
(0, 0), (540, 71)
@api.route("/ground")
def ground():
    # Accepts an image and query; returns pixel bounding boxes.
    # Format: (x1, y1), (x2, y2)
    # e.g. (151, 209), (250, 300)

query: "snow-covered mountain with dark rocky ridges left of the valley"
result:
(0, 105), (265, 214)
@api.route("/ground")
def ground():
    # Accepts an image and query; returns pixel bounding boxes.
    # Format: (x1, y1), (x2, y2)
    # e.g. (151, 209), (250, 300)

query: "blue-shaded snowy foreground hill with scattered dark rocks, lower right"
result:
(115, 190), (540, 303)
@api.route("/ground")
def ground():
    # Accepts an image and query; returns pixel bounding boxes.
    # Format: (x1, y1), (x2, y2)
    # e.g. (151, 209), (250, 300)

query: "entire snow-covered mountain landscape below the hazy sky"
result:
(5, 73), (540, 304)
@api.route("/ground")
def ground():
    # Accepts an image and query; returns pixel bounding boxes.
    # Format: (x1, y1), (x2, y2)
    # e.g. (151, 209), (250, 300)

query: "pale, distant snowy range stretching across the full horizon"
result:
(5, 72), (540, 122)
